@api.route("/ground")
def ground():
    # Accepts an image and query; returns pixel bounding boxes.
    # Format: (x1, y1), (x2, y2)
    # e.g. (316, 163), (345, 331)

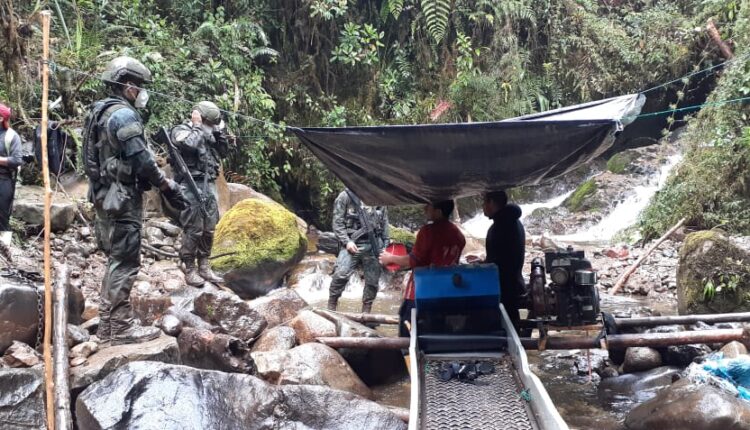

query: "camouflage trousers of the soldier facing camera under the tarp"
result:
(328, 244), (382, 303)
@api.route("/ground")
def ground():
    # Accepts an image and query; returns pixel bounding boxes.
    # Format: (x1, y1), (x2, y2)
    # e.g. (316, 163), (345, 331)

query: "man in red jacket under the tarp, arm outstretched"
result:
(380, 200), (466, 337)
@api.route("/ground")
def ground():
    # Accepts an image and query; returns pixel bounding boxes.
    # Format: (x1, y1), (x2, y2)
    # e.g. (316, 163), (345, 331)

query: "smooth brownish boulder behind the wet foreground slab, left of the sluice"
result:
(250, 342), (373, 399)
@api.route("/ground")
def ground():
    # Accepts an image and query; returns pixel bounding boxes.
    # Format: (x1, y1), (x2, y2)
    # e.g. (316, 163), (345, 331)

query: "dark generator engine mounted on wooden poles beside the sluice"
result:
(528, 247), (599, 327)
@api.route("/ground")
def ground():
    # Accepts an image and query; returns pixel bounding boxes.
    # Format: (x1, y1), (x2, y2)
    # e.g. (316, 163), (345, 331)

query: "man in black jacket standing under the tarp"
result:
(483, 191), (526, 331)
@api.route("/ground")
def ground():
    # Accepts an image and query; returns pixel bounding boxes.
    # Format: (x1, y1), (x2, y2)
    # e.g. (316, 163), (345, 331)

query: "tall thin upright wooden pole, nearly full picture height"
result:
(41, 11), (55, 430)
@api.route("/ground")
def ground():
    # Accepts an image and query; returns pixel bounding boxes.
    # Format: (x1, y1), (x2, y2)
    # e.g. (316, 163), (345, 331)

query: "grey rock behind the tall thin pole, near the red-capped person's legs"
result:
(13, 185), (78, 232)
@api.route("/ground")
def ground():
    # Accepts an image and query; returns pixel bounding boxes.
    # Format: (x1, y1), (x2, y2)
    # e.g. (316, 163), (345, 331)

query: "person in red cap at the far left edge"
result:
(0, 103), (23, 231)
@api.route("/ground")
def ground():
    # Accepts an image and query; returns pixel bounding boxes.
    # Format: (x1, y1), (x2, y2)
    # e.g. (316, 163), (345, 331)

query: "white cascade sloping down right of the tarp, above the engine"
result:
(554, 154), (682, 242)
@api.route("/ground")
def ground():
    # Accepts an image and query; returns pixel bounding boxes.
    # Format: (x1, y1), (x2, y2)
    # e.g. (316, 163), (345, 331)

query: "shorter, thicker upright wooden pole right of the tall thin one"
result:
(52, 264), (73, 430)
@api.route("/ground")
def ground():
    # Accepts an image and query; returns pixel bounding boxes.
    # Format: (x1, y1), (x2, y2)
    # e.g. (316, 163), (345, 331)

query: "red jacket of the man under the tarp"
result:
(404, 220), (466, 300)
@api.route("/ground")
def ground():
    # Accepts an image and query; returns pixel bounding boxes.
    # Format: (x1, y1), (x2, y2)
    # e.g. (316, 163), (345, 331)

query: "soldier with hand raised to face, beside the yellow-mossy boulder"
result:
(171, 101), (229, 287)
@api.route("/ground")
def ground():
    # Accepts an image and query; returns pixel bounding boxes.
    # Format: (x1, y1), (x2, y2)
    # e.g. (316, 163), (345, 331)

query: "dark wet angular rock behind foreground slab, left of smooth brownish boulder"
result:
(177, 327), (254, 373)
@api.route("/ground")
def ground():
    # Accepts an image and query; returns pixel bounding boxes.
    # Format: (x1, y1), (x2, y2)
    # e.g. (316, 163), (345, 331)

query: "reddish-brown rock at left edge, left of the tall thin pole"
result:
(0, 279), (39, 353)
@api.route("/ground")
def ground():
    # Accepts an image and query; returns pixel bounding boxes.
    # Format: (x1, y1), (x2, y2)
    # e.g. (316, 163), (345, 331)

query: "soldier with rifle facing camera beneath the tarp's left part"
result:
(328, 190), (390, 313)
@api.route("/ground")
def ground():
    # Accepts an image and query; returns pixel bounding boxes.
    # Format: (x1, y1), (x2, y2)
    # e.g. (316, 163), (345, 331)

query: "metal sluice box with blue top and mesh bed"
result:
(409, 265), (568, 430)
